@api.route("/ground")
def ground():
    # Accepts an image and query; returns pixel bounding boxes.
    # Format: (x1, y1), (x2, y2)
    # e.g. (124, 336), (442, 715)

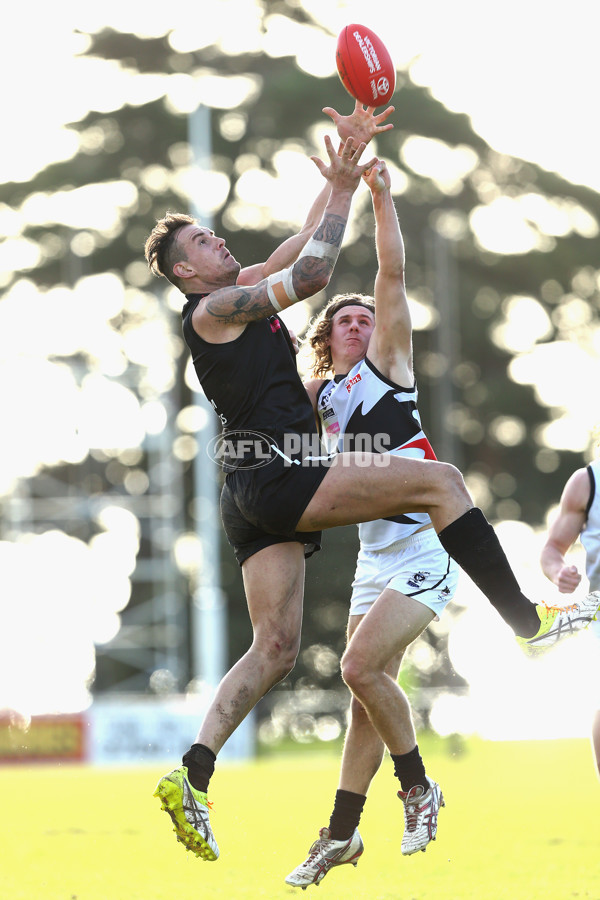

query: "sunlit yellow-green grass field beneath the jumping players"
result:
(0, 738), (600, 900)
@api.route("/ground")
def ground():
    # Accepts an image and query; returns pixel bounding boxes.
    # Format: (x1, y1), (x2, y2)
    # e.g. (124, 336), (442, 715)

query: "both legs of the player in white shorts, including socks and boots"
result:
(286, 589), (443, 888)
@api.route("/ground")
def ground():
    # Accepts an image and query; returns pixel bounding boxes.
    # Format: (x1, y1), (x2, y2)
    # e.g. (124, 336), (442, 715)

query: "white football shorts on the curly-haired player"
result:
(350, 528), (460, 618)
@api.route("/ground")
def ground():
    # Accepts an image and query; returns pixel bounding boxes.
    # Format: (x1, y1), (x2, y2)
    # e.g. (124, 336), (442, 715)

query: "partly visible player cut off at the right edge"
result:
(541, 459), (600, 775)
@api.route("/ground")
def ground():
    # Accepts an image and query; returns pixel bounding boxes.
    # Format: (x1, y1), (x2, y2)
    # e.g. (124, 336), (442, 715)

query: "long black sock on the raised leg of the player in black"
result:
(438, 508), (540, 637)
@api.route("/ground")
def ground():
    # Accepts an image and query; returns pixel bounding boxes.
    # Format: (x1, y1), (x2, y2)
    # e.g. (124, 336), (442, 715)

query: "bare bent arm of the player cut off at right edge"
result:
(540, 469), (590, 594)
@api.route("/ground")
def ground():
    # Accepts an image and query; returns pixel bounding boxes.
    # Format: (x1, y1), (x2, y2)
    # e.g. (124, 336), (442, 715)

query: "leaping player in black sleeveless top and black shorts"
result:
(146, 104), (595, 860)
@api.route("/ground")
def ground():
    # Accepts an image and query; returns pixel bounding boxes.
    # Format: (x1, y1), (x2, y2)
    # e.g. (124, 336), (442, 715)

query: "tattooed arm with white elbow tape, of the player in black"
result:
(192, 137), (377, 343)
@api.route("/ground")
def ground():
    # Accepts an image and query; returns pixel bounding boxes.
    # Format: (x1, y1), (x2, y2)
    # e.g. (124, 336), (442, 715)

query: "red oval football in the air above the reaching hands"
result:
(335, 25), (396, 106)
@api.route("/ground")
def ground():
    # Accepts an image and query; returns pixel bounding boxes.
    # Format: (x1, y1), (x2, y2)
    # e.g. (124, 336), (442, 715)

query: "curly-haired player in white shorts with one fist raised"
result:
(286, 156), (458, 887)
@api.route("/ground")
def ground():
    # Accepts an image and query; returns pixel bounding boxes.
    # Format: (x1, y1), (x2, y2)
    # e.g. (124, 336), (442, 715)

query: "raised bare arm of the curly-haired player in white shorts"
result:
(363, 161), (413, 386)
